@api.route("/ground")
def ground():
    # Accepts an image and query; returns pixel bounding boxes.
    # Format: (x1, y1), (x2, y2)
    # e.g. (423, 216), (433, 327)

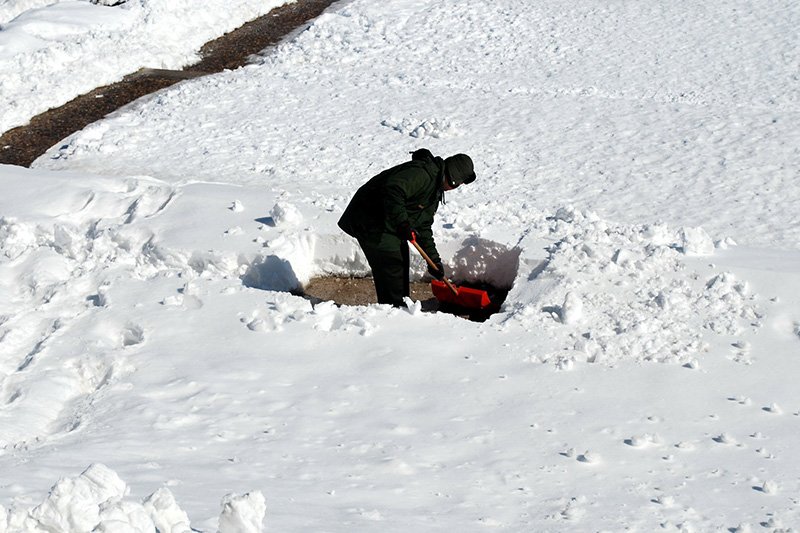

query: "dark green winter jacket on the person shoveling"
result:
(339, 157), (444, 262)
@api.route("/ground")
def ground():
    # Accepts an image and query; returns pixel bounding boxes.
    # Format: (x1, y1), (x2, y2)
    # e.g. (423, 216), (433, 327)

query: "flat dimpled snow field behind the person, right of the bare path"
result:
(39, 0), (800, 249)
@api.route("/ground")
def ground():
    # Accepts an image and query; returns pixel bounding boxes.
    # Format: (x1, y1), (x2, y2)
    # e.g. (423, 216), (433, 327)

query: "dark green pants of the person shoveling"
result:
(358, 233), (409, 307)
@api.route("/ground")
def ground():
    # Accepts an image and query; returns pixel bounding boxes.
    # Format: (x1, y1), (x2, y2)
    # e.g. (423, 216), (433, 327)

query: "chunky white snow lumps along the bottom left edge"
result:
(0, 464), (266, 533)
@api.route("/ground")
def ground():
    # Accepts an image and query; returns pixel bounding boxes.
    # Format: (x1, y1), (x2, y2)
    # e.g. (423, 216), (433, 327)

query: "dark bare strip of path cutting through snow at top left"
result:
(0, 0), (336, 167)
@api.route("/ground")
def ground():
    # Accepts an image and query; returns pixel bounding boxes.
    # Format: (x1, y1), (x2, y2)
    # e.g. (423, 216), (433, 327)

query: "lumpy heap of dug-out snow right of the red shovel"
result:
(505, 208), (762, 366)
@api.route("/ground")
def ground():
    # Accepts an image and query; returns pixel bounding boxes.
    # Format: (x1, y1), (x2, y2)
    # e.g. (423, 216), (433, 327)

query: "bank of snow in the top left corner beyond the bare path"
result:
(0, 0), (294, 133)
